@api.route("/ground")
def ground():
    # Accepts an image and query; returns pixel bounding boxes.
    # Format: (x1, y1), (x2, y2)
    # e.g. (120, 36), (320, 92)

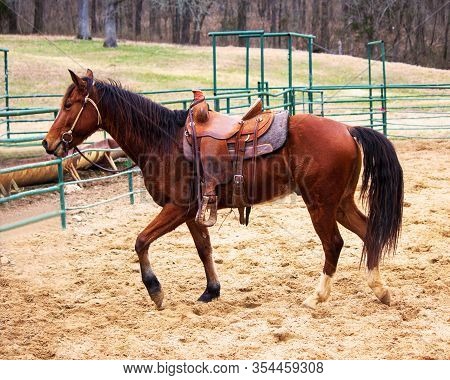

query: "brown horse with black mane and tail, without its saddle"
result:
(42, 70), (403, 308)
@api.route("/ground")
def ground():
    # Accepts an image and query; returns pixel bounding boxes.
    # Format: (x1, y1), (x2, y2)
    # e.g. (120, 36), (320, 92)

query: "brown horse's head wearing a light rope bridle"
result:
(42, 69), (101, 157)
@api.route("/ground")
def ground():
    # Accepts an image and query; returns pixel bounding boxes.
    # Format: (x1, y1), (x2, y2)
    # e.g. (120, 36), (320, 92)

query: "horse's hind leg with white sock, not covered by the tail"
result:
(303, 204), (344, 309)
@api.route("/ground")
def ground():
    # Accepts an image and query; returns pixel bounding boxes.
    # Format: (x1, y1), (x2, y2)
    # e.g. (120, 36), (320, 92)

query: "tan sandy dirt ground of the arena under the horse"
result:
(0, 140), (450, 359)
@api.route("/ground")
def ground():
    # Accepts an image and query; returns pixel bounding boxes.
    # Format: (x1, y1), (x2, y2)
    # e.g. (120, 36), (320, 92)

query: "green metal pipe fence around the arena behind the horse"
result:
(0, 34), (450, 232)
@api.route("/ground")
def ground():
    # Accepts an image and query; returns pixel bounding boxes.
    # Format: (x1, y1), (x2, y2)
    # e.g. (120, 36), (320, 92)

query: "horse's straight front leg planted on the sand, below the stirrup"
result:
(186, 220), (220, 302)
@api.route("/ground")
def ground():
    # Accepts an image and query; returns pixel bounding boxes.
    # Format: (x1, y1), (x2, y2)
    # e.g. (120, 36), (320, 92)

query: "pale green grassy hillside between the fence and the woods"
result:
(0, 35), (450, 101)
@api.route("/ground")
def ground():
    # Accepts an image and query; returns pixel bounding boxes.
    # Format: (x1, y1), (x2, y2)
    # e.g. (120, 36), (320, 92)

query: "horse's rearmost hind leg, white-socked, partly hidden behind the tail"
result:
(337, 197), (391, 305)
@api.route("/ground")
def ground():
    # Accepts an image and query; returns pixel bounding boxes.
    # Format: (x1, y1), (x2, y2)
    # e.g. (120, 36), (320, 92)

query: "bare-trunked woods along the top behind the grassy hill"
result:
(0, 0), (450, 68)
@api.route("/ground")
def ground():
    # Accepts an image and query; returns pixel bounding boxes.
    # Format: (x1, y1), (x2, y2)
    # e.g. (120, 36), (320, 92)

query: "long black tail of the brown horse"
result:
(349, 127), (403, 270)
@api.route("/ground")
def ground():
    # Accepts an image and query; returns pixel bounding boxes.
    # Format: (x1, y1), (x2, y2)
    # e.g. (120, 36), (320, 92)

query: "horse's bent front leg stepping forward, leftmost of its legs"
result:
(135, 203), (187, 310)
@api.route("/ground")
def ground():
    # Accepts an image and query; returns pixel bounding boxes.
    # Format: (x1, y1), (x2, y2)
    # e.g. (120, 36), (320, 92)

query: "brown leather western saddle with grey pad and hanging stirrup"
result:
(183, 90), (288, 227)
